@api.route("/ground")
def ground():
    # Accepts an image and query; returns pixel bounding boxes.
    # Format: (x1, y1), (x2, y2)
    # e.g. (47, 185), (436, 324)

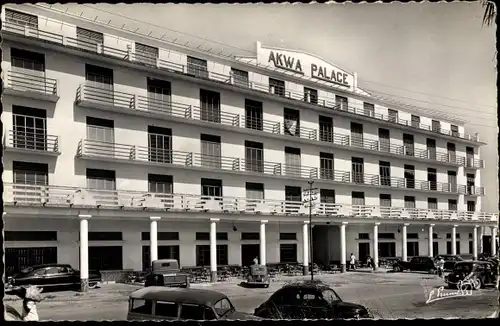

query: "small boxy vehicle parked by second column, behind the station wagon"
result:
(144, 259), (190, 288)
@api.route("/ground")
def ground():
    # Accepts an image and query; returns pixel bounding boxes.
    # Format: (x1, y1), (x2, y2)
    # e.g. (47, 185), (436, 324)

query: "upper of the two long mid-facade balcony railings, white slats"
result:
(76, 84), (468, 165)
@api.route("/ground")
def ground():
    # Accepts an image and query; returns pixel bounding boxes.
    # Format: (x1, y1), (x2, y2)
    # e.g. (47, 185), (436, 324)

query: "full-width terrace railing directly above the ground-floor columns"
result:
(4, 183), (498, 223)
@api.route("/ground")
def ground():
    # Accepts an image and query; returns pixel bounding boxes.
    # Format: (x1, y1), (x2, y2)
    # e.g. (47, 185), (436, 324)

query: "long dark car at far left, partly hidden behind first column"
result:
(6, 264), (102, 291)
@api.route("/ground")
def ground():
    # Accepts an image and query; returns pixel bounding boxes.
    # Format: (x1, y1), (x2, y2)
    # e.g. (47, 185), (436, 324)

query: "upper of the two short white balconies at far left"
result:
(4, 70), (59, 103)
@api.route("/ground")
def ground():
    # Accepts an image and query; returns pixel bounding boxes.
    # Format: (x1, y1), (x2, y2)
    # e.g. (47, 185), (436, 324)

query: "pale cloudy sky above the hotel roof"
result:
(38, 2), (499, 212)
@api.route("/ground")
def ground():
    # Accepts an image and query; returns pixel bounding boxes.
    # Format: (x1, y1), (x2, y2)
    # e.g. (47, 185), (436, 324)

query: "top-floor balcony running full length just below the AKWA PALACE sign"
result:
(3, 22), (482, 145)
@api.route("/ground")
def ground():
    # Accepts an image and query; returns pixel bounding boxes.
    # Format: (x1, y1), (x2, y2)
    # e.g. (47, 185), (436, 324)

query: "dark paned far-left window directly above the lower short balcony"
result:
(12, 105), (47, 151)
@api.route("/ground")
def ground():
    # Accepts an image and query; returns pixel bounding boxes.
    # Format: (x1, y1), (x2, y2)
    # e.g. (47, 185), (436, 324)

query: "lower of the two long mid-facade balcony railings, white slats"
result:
(77, 139), (478, 195)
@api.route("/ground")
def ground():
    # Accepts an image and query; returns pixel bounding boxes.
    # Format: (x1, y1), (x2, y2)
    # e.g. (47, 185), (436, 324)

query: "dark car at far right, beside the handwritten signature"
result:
(445, 260), (497, 290)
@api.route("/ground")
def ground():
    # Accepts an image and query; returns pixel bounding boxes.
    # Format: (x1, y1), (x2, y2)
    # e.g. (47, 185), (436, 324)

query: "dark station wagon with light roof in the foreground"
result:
(127, 286), (260, 320)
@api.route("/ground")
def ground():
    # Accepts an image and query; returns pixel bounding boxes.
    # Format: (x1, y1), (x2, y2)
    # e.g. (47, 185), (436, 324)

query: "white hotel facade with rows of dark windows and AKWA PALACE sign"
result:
(2, 4), (497, 276)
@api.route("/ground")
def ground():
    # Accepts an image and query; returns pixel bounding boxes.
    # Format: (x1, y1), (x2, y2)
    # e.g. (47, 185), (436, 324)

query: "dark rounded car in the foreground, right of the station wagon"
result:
(254, 281), (373, 319)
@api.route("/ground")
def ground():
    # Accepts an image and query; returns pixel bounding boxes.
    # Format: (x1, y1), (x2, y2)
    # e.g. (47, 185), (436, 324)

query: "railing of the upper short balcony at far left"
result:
(5, 70), (57, 96)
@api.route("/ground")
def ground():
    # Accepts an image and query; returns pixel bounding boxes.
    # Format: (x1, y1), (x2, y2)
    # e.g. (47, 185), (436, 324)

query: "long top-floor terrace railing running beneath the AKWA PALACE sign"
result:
(3, 22), (479, 142)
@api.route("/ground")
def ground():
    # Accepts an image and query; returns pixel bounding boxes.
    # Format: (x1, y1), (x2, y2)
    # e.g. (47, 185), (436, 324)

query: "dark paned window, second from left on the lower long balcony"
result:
(148, 126), (173, 164)
